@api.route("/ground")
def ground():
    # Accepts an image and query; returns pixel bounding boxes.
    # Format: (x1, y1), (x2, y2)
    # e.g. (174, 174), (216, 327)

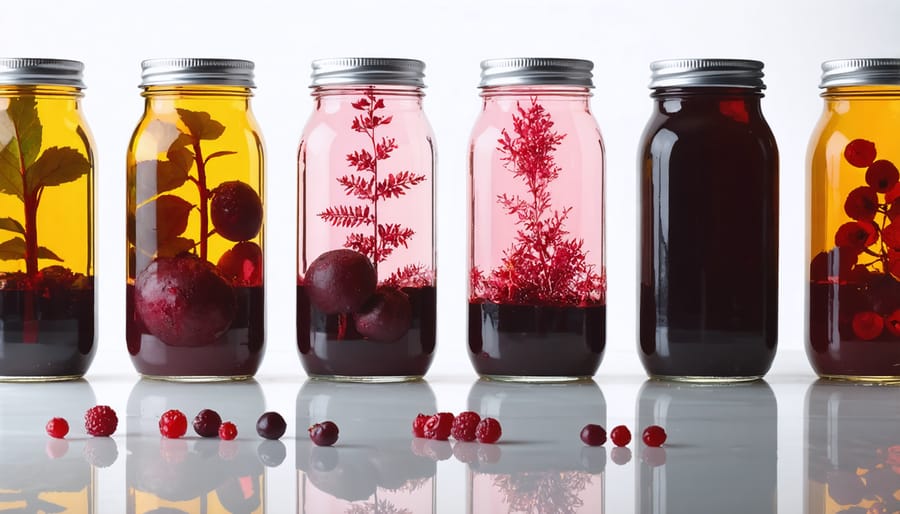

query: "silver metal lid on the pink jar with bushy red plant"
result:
(478, 57), (594, 87)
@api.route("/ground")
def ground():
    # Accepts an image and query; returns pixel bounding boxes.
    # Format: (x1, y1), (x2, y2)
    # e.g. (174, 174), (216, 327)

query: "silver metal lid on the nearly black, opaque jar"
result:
(649, 59), (766, 89)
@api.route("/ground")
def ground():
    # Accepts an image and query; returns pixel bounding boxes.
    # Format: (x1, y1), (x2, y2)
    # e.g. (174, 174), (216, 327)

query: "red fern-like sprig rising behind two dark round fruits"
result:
(319, 90), (432, 287)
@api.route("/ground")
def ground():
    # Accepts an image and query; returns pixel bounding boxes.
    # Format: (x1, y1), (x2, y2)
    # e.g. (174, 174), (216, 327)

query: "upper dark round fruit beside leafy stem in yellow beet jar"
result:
(209, 180), (263, 241)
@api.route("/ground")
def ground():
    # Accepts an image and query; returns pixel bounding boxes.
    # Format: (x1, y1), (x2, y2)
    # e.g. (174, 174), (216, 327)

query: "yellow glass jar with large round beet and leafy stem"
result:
(126, 59), (264, 380)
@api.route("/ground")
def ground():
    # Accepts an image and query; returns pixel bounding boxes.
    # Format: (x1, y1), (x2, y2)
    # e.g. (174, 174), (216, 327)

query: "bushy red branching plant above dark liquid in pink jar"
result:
(470, 99), (606, 306)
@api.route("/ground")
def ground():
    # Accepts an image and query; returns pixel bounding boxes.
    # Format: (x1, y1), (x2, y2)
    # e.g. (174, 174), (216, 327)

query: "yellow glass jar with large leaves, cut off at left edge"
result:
(0, 58), (96, 381)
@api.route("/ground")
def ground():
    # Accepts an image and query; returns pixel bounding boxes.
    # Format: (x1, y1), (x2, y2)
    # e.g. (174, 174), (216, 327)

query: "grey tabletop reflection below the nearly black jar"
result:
(633, 381), (778, 514)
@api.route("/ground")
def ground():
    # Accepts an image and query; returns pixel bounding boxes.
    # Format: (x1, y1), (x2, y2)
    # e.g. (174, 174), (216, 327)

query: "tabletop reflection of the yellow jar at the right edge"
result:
(805, 380), (900, 514)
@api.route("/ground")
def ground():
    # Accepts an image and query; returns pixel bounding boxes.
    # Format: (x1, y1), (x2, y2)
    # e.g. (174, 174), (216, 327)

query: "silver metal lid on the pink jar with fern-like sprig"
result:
(309, 57), (425, 87)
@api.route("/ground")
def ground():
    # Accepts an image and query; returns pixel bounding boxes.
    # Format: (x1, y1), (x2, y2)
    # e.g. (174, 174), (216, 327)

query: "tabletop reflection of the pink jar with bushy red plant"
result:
(464, 380), (606, 514)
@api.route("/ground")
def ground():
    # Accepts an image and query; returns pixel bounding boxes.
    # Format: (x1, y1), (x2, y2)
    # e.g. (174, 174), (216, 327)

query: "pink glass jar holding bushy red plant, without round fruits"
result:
(468, 58), (606, 381)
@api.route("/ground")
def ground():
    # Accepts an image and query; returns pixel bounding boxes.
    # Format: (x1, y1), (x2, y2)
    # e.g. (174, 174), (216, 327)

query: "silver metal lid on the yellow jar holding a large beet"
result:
(141, 58), (256, 87)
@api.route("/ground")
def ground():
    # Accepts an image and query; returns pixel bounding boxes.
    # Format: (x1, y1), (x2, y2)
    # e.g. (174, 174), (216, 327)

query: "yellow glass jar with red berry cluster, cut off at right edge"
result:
(806, 59), (900, 381)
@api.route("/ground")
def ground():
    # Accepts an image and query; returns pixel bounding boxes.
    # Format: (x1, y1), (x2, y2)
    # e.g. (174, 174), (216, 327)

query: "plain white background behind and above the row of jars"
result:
(0, 0), (900, 377)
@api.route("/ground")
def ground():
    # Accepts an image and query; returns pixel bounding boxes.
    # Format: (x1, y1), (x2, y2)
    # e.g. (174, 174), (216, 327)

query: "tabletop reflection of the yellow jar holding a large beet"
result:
(125, 380), (265, 514)
